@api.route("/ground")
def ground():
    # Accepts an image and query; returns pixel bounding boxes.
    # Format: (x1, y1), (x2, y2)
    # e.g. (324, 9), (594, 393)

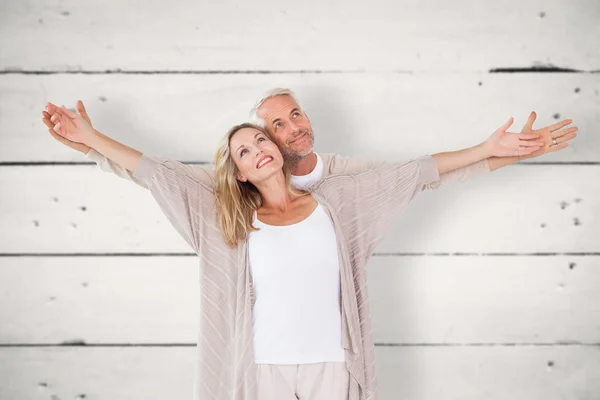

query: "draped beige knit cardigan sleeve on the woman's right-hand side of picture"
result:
(314, 155), (440, 263)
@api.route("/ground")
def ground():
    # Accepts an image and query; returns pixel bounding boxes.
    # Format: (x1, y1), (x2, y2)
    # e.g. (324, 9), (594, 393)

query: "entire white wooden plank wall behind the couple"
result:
(0, 0), (600, 400)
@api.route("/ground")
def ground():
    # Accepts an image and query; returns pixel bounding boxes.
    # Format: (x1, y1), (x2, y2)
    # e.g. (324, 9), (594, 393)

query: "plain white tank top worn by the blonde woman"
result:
(248, 204), (345, 364)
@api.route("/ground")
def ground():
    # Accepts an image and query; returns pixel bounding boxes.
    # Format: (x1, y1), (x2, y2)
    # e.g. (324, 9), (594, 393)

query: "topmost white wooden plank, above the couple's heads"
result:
(0, 0), (600, 72)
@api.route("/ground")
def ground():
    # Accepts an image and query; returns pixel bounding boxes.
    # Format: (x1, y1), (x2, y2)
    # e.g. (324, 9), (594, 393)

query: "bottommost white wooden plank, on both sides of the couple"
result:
(0, 346), (600, 400)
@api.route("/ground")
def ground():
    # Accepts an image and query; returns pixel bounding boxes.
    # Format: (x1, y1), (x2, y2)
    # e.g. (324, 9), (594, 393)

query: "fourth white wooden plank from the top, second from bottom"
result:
(0, 256), (600, 345)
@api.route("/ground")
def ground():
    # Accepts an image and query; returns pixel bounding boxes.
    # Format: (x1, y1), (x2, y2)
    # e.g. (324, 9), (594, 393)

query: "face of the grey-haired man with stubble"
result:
(258, 95), (315, 163)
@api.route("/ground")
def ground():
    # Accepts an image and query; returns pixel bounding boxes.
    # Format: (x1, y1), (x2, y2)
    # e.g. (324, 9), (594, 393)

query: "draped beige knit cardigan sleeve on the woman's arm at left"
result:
(133, 154), (214, 254)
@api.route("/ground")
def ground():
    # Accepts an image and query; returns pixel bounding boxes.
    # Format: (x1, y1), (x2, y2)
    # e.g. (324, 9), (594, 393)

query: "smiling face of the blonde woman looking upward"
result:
(229, 128), (283, 186)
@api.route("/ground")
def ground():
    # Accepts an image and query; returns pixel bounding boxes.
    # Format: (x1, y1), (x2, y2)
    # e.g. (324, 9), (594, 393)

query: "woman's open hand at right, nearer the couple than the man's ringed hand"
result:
(484, 117), (544, 157)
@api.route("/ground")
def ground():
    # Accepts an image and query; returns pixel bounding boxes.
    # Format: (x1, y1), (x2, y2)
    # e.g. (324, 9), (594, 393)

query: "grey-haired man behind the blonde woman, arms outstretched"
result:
(43, 88), (577, 189)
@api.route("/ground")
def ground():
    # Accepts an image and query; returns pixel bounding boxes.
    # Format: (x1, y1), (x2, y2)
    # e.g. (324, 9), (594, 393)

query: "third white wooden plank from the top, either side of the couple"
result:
(0, 165), (600, 254)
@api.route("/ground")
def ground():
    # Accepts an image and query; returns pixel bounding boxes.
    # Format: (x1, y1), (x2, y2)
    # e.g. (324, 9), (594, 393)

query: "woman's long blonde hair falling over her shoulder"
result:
(215, 123), (304, 247)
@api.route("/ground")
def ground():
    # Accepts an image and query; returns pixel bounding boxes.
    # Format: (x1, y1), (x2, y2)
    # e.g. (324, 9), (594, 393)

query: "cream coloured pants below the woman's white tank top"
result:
(257, 362), (350, 400)
